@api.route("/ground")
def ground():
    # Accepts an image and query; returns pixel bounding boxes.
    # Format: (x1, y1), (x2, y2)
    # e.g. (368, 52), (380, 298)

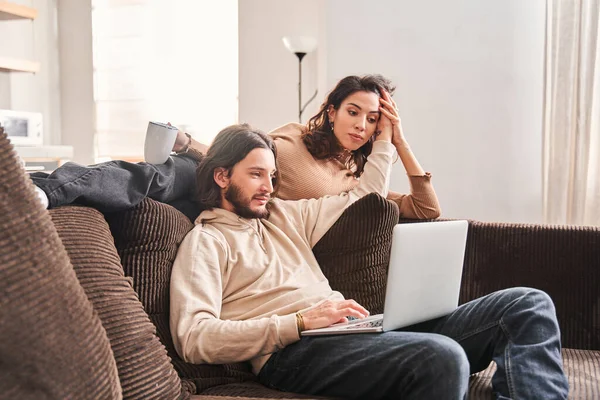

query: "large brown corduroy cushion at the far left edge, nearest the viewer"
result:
(0, 128), (121, 400)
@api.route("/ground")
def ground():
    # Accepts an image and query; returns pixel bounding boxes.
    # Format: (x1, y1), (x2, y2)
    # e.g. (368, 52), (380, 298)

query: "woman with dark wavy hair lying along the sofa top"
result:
(32, 75), (440, 219)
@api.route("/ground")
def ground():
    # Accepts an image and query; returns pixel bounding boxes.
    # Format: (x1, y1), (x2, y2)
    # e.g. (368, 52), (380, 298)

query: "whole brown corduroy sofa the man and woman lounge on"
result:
(0, 124), (600, 400)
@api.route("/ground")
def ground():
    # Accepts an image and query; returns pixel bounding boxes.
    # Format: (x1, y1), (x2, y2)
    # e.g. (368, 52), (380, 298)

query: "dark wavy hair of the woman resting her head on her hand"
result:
(302, 75), (396, 178)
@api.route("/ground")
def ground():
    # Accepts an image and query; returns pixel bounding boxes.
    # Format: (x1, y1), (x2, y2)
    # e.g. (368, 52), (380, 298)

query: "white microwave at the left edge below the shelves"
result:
(0, 110), (44, 146)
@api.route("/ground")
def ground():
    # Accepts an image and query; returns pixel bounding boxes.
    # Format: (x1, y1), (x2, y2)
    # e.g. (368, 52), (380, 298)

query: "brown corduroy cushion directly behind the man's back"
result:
(105, 199), (256, 393)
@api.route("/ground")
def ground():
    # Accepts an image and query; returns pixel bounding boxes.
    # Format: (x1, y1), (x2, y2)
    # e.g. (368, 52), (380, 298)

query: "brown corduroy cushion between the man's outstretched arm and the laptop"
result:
(313, 193), (399, 314)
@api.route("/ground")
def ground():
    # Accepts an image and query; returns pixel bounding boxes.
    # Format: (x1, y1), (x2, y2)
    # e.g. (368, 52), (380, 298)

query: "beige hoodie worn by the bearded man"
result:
(170, 141), (395, 374)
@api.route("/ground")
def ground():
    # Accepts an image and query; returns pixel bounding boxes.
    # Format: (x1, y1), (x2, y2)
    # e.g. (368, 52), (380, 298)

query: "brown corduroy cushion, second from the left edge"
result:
(50, 206), (182, 400)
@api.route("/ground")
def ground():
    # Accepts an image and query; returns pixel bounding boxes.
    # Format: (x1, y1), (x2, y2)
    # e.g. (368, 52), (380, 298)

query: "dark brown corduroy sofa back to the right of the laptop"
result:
(460, 221), (600, 350)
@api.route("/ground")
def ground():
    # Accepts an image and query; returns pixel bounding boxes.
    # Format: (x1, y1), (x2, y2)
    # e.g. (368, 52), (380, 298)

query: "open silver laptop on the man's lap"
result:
(302, 221), (469, 336)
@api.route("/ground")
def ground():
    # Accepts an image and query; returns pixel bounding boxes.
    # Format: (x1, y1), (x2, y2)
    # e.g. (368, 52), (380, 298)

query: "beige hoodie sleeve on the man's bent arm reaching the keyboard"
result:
(170, 226), (299, 364)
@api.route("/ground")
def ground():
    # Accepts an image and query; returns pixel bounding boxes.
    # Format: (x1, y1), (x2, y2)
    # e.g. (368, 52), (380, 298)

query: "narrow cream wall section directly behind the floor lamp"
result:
(238, 0), (323, 131)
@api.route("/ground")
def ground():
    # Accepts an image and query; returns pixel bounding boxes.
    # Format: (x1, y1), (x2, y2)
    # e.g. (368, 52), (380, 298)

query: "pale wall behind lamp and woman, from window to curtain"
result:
(240, 0), (545, 222)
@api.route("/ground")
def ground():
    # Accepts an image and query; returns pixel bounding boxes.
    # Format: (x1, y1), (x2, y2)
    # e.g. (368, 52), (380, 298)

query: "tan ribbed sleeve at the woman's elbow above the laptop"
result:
(387, 172), (442, 219)
